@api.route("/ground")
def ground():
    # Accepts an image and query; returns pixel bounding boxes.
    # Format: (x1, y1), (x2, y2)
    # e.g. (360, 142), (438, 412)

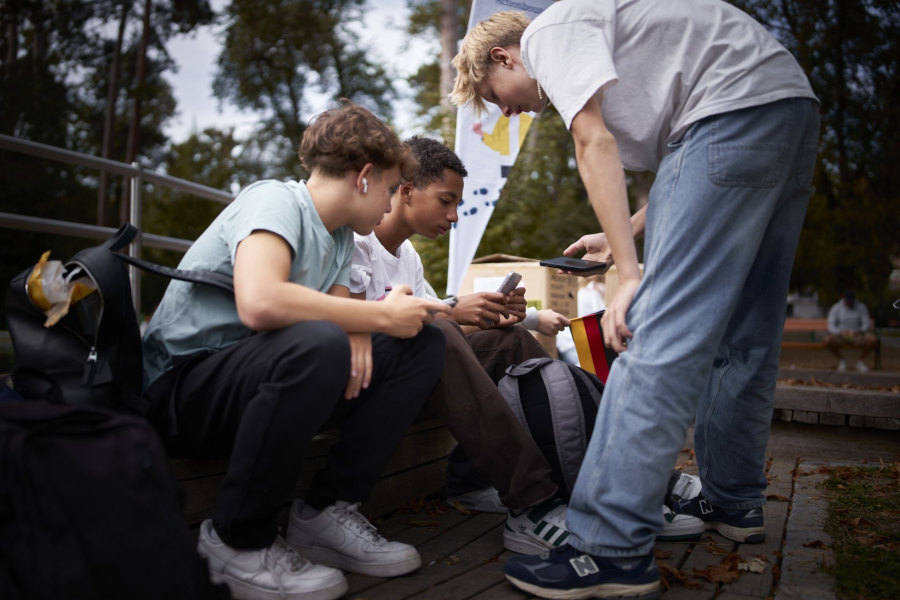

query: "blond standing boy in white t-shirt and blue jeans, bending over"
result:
(452, 0), (819, 598)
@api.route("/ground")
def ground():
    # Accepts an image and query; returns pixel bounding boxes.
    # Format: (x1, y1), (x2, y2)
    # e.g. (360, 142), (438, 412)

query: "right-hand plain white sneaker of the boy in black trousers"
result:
(286, 500), (422, 577)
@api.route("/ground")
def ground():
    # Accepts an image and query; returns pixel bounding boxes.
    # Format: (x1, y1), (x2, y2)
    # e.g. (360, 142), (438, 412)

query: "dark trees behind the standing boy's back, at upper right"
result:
(734, 0), (900, 322)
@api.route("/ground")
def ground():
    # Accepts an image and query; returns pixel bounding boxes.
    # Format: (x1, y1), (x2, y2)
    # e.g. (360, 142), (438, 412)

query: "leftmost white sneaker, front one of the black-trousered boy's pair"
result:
(197, 519), (347, 600)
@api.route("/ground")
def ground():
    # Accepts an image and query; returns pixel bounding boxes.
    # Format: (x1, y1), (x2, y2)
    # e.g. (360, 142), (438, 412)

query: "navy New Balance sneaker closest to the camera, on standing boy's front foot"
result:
(503, 544), (659, 600)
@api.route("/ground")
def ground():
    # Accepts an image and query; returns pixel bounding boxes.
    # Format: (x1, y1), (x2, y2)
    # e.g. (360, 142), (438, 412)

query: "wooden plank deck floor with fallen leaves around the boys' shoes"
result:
(338, 453), (797, 600)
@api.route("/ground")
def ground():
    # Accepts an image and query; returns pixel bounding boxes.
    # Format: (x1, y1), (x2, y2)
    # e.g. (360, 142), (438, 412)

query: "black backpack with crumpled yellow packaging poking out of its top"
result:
(6, 223), (234, 414)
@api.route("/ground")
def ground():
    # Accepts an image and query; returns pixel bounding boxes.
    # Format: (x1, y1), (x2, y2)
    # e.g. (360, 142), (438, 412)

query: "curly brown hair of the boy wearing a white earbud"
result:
(297, 99), (418, 179)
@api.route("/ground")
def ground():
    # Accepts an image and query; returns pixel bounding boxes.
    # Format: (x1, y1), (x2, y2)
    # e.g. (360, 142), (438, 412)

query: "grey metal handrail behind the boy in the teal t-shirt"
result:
(0, 134), (234, 314)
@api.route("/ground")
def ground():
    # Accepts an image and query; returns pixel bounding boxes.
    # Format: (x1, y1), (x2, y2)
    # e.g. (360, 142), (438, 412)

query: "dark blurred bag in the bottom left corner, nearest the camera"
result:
(0, 400), (229, 600)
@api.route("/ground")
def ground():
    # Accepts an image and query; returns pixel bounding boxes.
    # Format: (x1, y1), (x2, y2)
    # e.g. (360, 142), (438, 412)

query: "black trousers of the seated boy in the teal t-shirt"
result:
(148, 321), (445, 549)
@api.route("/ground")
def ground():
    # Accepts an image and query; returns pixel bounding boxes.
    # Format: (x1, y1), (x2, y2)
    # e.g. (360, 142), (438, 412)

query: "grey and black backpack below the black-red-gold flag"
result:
(497, 358), (603, 500)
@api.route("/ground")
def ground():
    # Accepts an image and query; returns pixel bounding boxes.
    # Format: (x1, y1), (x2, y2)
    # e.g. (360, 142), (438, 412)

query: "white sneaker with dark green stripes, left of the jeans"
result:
(503, 498), (569, 554)
